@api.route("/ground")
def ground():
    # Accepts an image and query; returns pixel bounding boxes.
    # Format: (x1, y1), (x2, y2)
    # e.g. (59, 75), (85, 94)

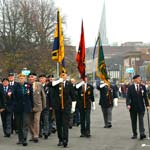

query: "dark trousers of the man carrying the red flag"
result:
(80, 109), (91, 135)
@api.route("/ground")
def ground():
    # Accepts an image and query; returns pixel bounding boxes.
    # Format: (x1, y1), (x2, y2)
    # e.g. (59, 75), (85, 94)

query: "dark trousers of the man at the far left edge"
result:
(1, 110), (12, 135)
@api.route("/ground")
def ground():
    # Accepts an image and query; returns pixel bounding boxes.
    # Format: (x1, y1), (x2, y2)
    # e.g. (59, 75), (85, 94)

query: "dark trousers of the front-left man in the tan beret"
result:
(16, 112), (30, 143)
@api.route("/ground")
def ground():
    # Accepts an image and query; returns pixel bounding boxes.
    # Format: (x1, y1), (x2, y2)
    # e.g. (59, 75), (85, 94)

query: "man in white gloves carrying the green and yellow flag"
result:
(97, 81), (118, 128)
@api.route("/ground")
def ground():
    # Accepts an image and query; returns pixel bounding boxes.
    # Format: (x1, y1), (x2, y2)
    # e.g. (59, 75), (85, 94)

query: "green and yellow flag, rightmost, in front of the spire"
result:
(96, 34), (109, 83)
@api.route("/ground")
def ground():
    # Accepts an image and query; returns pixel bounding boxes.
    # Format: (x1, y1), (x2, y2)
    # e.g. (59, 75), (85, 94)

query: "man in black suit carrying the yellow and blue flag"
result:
(52, 71), (75, 147)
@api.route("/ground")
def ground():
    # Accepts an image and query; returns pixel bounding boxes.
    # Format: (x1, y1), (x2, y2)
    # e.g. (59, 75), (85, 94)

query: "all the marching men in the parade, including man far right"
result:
(0, 71), (150, 147)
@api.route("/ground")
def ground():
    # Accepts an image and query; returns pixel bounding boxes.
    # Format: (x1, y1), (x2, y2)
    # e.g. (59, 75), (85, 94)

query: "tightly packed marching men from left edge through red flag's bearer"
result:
(0, 71), (95, 147)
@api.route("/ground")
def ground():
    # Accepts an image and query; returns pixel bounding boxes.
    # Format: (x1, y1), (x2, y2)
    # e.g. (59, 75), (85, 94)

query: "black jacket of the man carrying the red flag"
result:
(77, 83), (95, 109)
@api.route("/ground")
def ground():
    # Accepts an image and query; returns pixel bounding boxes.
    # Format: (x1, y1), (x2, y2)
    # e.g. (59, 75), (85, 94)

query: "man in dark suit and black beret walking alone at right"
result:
(126, 75), (149, 140)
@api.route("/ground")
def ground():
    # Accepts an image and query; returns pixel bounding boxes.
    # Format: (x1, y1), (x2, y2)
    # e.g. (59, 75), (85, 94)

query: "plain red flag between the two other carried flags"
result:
(76, 21), (85, 80)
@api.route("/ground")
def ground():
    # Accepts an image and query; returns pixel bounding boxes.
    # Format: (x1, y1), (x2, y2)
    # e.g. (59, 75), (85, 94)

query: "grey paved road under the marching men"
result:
(0, 99), (150, 150)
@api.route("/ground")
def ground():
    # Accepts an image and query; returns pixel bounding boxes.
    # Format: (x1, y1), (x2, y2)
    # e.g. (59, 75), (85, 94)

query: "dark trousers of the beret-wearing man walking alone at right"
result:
(130, 111), (145, 135)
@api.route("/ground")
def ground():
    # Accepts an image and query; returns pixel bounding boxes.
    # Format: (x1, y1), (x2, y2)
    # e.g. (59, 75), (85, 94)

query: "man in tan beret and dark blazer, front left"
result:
(14, 74), (33, 146)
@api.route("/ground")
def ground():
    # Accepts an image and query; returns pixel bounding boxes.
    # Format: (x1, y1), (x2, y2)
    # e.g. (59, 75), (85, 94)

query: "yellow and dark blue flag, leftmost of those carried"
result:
(52, 10), (64, 63)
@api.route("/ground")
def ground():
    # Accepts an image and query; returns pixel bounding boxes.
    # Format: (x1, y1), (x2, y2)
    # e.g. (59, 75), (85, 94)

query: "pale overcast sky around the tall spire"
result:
(55, 0), (150, 47)
